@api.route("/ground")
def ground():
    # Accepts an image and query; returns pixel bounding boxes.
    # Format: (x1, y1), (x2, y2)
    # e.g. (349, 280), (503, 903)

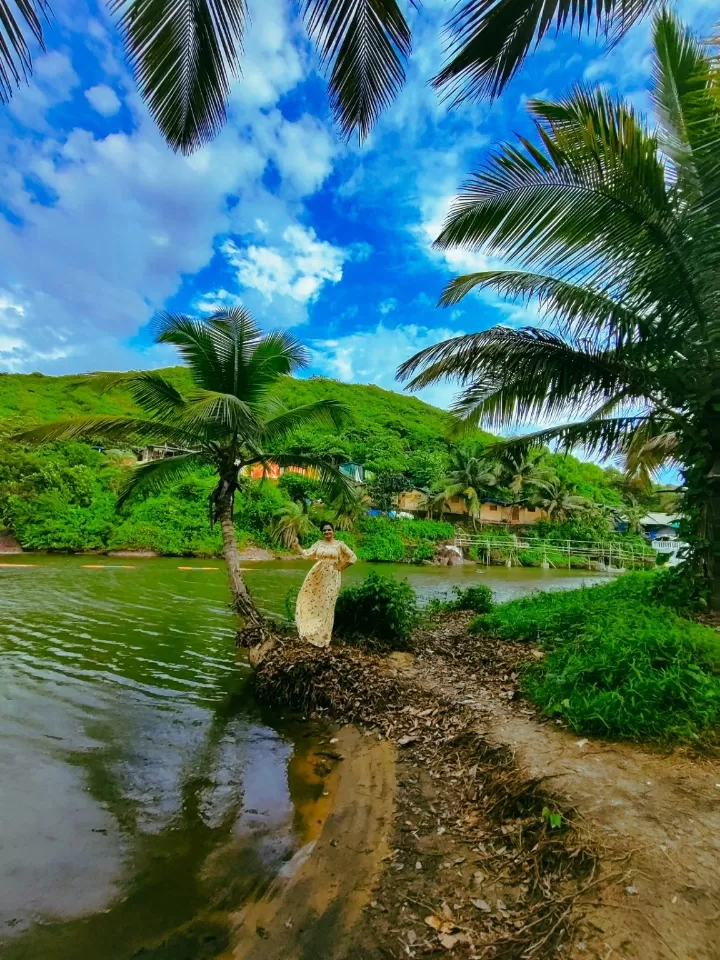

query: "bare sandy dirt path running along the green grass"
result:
(414, 624), (720, 960)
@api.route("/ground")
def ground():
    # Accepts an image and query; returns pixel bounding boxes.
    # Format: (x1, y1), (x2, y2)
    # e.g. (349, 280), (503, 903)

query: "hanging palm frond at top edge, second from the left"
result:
(110, 0), (247, 154)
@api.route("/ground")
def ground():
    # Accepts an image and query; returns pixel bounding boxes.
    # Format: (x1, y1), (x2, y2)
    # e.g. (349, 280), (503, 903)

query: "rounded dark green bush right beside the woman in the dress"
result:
(335, 571), (420, 650)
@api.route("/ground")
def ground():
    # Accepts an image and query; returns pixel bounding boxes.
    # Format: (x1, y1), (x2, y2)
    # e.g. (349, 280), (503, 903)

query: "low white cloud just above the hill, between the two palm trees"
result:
(311, 321), (463, 408)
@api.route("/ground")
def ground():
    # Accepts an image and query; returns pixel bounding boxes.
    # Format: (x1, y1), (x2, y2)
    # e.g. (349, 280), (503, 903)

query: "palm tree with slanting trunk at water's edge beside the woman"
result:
(15, 307), (348, 645)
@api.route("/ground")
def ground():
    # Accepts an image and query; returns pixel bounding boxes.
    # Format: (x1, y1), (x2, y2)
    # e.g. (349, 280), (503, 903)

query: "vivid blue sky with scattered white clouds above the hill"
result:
(0, 0), (714, 416)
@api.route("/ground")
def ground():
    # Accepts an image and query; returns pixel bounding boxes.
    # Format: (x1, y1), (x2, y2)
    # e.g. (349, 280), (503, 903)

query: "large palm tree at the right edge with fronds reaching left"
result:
(399, 12), (720, 607)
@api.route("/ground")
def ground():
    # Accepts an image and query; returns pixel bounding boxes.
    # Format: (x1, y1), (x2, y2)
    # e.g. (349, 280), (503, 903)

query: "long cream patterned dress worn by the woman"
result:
(295, 540), (357, 647)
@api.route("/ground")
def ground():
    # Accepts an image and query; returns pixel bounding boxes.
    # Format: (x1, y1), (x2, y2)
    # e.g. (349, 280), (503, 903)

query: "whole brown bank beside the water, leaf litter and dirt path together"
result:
(249, 614), (720, 960)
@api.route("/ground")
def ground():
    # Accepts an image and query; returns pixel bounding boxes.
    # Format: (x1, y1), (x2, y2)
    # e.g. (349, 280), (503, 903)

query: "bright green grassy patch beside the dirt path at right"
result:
(472, 571), (720, 739)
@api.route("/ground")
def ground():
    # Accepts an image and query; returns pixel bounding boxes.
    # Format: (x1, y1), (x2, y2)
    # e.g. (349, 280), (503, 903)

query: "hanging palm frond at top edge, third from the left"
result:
(304, 0), (411, 141)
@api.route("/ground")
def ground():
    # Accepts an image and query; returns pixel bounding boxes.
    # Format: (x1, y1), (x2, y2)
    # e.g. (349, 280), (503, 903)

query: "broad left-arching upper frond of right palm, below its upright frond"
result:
(436, 88), (709, 329)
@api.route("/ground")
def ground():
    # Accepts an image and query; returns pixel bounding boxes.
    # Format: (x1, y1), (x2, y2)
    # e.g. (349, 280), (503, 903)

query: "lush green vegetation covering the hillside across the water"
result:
(0, 367), (664, 565)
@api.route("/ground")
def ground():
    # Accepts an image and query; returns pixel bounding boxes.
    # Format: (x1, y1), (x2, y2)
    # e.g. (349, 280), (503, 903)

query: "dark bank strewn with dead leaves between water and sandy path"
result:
(253, 644), (601, 960)
